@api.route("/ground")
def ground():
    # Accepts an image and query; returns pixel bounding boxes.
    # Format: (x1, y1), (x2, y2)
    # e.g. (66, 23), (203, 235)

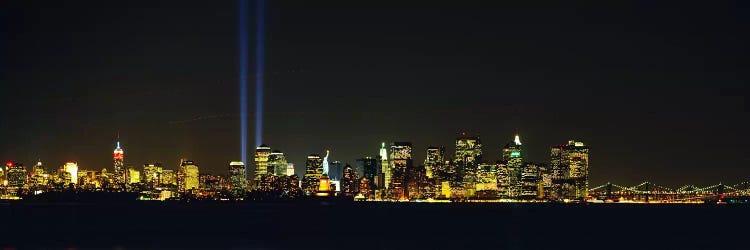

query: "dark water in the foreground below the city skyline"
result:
(0, 202), (750, 249)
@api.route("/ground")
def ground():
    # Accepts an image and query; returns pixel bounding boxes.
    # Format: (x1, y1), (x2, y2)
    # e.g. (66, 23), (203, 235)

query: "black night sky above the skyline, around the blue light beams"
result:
(0, 1), (750, 186)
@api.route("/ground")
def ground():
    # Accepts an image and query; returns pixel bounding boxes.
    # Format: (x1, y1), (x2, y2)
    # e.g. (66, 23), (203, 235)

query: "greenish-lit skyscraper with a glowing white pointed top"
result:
(498, 134), (523, 198)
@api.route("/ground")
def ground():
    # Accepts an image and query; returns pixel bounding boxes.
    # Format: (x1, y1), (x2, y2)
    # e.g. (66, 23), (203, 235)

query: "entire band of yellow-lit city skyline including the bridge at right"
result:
(0, 133), (748, 203)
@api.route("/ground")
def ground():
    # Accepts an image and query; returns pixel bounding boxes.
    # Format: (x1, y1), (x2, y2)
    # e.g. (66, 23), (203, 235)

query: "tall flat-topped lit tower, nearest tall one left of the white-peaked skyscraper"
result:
(454, 133), (482, 181)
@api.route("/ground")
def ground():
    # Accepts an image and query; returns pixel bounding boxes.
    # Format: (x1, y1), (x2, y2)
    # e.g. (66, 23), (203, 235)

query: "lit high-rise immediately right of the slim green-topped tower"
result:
(386, 142), (412, 200)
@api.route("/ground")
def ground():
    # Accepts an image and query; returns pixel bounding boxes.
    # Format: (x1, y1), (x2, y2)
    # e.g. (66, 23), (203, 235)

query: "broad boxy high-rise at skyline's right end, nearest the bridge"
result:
(550, 140), (589, 199)
